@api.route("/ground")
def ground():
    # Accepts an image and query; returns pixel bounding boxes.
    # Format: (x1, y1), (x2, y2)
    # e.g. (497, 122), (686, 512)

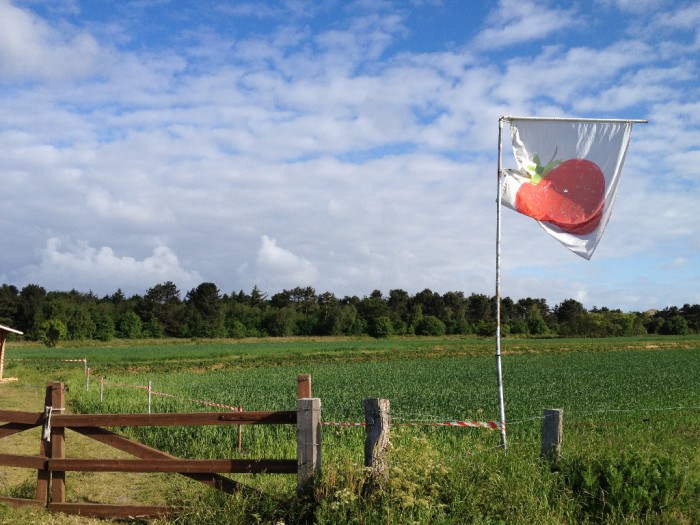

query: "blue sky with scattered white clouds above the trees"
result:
(0, 0), (700, 311)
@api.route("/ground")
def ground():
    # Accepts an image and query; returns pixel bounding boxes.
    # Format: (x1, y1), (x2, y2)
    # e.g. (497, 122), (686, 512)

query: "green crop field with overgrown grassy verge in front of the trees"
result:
(1, 336), (700, 524)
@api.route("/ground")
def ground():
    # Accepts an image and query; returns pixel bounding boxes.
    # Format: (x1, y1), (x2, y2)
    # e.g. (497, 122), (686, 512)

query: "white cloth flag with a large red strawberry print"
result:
(501, 117), (632, 259)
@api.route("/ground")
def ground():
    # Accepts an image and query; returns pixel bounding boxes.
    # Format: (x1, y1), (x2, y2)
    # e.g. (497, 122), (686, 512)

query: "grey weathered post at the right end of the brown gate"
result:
(297, 398), (321, 495)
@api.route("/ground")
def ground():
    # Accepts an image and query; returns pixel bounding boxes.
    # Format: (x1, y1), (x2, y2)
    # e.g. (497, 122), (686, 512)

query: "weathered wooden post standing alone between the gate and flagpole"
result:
(365, 399), (391, 488)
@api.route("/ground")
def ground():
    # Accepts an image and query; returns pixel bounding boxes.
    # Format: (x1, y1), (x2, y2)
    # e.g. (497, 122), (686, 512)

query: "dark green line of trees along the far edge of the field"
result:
(0, 281), (700, 346)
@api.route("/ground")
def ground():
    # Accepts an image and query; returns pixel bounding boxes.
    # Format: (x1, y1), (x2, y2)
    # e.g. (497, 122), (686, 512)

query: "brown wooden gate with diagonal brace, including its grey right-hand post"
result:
(0, 376), (321, 518)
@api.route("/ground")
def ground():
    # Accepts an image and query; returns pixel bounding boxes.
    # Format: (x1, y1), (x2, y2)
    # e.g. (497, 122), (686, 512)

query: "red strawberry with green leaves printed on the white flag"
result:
(515, 151), (605, 235)
